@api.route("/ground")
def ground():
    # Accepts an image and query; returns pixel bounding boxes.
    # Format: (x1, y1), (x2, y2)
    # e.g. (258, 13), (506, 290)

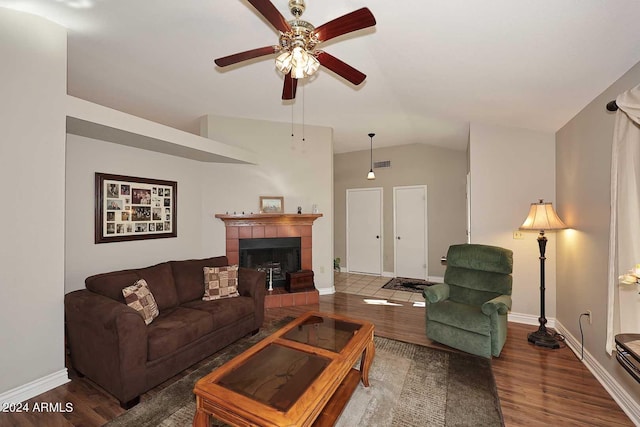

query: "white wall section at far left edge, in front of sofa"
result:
(0, 8), (67, 401)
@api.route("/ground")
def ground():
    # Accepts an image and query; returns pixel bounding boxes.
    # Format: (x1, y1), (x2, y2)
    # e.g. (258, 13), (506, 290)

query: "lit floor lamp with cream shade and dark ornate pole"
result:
(520, 199), (567, 348)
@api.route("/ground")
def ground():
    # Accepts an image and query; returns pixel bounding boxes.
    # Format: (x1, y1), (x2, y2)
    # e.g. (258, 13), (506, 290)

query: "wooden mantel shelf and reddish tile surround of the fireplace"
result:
(215, 213), (322, 270)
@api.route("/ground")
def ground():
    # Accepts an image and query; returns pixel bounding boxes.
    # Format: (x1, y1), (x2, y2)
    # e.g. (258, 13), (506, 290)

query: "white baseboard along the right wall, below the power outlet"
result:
(556, 322), (640, 425)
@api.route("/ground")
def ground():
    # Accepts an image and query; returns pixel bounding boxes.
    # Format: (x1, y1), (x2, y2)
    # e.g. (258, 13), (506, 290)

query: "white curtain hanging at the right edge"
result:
(606, 85), (640, 354)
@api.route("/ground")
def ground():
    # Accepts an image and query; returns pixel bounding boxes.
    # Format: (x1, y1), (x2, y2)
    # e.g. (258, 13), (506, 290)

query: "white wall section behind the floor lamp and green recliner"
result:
(469, 123), (556, 323)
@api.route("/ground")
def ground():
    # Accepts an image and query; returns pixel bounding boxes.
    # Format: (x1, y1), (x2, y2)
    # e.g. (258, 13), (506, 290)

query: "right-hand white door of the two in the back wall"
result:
(393, 185), (428, 280)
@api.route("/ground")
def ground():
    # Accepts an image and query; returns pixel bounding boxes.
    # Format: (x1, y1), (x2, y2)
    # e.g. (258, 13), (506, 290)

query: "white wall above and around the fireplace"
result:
(201, 116), (333, 293)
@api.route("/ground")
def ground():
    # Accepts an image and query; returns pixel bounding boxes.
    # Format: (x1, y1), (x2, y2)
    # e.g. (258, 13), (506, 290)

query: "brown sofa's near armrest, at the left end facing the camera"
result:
(64, 289), (147, 402)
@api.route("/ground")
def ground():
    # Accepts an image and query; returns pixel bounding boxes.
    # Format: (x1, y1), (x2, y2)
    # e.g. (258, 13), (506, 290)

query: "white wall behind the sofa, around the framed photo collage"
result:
(65, 134), (205, 292)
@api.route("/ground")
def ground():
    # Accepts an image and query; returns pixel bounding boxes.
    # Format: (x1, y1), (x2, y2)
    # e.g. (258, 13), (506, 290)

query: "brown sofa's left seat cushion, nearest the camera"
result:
(147, 307), (213, 360)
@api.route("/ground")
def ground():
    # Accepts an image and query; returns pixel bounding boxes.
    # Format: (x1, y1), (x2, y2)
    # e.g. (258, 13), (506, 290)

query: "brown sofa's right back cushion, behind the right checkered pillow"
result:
(170, 256), (229, 304)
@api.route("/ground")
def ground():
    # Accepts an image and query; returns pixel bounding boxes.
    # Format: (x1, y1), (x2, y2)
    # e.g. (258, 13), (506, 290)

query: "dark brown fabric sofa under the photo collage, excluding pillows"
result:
(65, 257), (265, 408)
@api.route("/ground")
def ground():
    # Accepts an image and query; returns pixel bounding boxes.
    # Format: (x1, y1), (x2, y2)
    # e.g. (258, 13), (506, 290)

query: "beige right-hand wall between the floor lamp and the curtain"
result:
(556, 60), (640, 406)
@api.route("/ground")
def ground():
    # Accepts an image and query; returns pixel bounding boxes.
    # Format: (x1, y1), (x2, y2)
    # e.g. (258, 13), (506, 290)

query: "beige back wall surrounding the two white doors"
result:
(333, 144), (467, 277)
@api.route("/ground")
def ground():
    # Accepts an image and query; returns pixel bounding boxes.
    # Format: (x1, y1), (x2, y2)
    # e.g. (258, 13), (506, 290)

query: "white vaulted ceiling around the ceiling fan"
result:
(5, 0), (640, 152)
